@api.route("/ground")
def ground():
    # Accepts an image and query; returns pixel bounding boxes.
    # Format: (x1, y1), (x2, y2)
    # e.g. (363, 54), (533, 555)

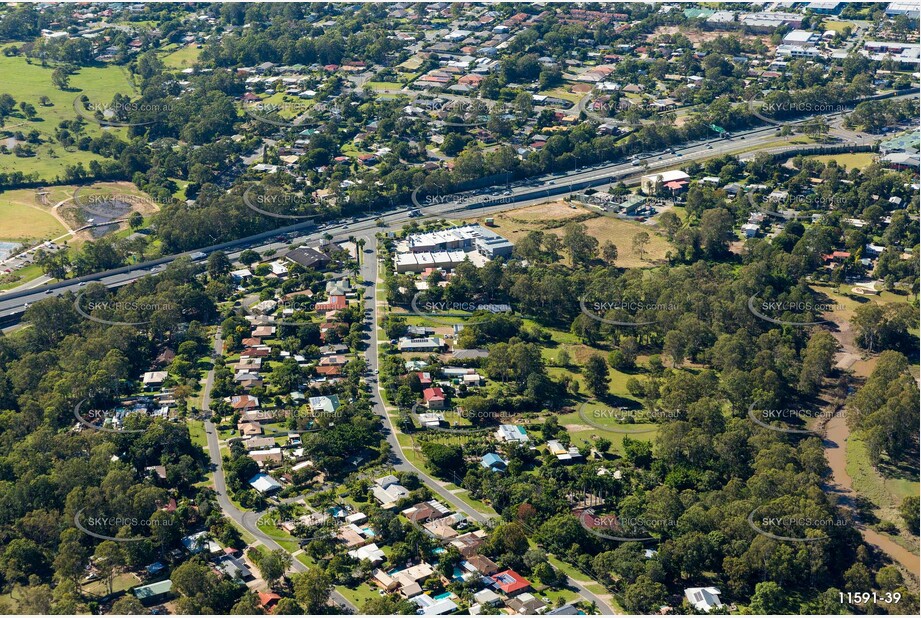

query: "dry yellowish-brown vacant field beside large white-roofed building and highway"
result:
(469, 202), (670, 268)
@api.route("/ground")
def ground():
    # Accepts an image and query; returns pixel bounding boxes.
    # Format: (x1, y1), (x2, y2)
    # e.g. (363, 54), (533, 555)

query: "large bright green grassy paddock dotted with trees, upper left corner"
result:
(0, 50), (134, 180)
